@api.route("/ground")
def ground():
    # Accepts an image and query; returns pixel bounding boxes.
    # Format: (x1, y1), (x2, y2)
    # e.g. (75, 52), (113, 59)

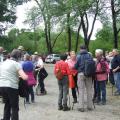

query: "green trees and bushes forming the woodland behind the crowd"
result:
(0, 0), (120, 54)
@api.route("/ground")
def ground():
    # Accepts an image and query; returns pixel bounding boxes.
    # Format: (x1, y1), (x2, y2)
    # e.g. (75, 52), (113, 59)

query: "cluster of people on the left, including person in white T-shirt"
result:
(0, 46), (46, 120)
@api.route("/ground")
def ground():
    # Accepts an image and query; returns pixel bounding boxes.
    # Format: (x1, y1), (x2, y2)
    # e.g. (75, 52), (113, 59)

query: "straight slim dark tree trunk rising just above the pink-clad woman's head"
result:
(67, 13), (71, 52)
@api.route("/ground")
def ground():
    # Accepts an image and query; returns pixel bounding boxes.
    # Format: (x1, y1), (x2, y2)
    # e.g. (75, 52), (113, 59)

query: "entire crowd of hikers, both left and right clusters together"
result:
(0, 45), (120, 120)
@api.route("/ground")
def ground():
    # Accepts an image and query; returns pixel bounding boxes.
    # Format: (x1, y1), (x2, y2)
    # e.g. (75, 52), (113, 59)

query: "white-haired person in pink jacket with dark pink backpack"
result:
(95, 49), (110, 105)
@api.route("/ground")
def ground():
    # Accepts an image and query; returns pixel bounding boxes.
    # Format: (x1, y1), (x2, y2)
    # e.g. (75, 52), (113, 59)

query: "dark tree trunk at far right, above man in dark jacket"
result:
(111, 0), (118, 48)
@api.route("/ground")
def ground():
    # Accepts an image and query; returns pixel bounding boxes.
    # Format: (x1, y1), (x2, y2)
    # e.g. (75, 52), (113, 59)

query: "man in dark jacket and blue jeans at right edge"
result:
(111, 49), (120, 95)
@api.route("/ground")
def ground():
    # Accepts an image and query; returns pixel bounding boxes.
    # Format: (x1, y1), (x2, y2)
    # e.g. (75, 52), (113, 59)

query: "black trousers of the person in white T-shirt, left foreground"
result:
(0, 87), (19, 120)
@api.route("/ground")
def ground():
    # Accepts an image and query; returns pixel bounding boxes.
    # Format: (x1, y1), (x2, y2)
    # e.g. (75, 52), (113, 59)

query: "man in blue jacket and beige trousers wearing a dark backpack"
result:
(74, 45), (95, 112)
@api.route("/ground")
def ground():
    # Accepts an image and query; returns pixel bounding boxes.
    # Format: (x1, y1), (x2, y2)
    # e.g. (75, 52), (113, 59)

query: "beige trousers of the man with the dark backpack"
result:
(77, 73), (93, 108)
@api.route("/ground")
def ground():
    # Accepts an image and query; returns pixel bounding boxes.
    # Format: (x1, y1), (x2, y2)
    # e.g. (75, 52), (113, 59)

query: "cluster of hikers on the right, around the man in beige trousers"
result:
(54, 45), (120, 112)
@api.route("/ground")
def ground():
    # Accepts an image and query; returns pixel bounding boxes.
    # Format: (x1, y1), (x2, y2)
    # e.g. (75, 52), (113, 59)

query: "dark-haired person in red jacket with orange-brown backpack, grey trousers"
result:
(54, 54), (70, 111)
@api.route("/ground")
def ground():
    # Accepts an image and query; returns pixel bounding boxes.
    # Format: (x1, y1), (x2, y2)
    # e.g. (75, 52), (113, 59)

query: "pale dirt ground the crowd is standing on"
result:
(0, 64), (120, 120)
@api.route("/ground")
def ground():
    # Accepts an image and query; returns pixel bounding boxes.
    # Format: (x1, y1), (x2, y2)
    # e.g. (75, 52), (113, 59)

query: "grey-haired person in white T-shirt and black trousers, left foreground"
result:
(0, 49), (28, 120)
